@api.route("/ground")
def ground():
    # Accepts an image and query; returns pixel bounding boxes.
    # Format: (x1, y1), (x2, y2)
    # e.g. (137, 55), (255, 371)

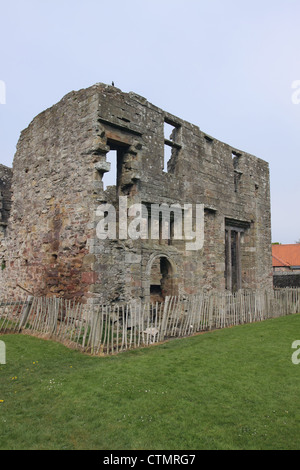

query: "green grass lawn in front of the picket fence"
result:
(0, 315), (300, 450)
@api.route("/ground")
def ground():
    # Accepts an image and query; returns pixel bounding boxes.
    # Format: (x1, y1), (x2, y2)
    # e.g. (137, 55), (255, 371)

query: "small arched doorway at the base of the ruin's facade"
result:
(147, 254), (178, 302)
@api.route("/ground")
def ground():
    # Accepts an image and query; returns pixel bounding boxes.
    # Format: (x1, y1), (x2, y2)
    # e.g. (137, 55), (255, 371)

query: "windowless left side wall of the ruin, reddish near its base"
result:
(1, 89), (103, 297)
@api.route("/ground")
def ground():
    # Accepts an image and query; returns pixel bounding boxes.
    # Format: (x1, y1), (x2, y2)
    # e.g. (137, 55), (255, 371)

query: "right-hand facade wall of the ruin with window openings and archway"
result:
(87, 89), (272, 301)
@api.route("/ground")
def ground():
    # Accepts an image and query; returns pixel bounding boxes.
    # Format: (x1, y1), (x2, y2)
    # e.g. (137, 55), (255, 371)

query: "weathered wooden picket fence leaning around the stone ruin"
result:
(0, 288), (300, 355)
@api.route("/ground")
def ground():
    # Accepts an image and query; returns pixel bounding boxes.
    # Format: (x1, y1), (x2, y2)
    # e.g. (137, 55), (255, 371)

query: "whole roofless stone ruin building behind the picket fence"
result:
(0, 83), (272, 303)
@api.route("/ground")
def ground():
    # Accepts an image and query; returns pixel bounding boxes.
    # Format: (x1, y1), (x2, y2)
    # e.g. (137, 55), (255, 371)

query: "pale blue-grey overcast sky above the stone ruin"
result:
(0, 0), (300, 243)
